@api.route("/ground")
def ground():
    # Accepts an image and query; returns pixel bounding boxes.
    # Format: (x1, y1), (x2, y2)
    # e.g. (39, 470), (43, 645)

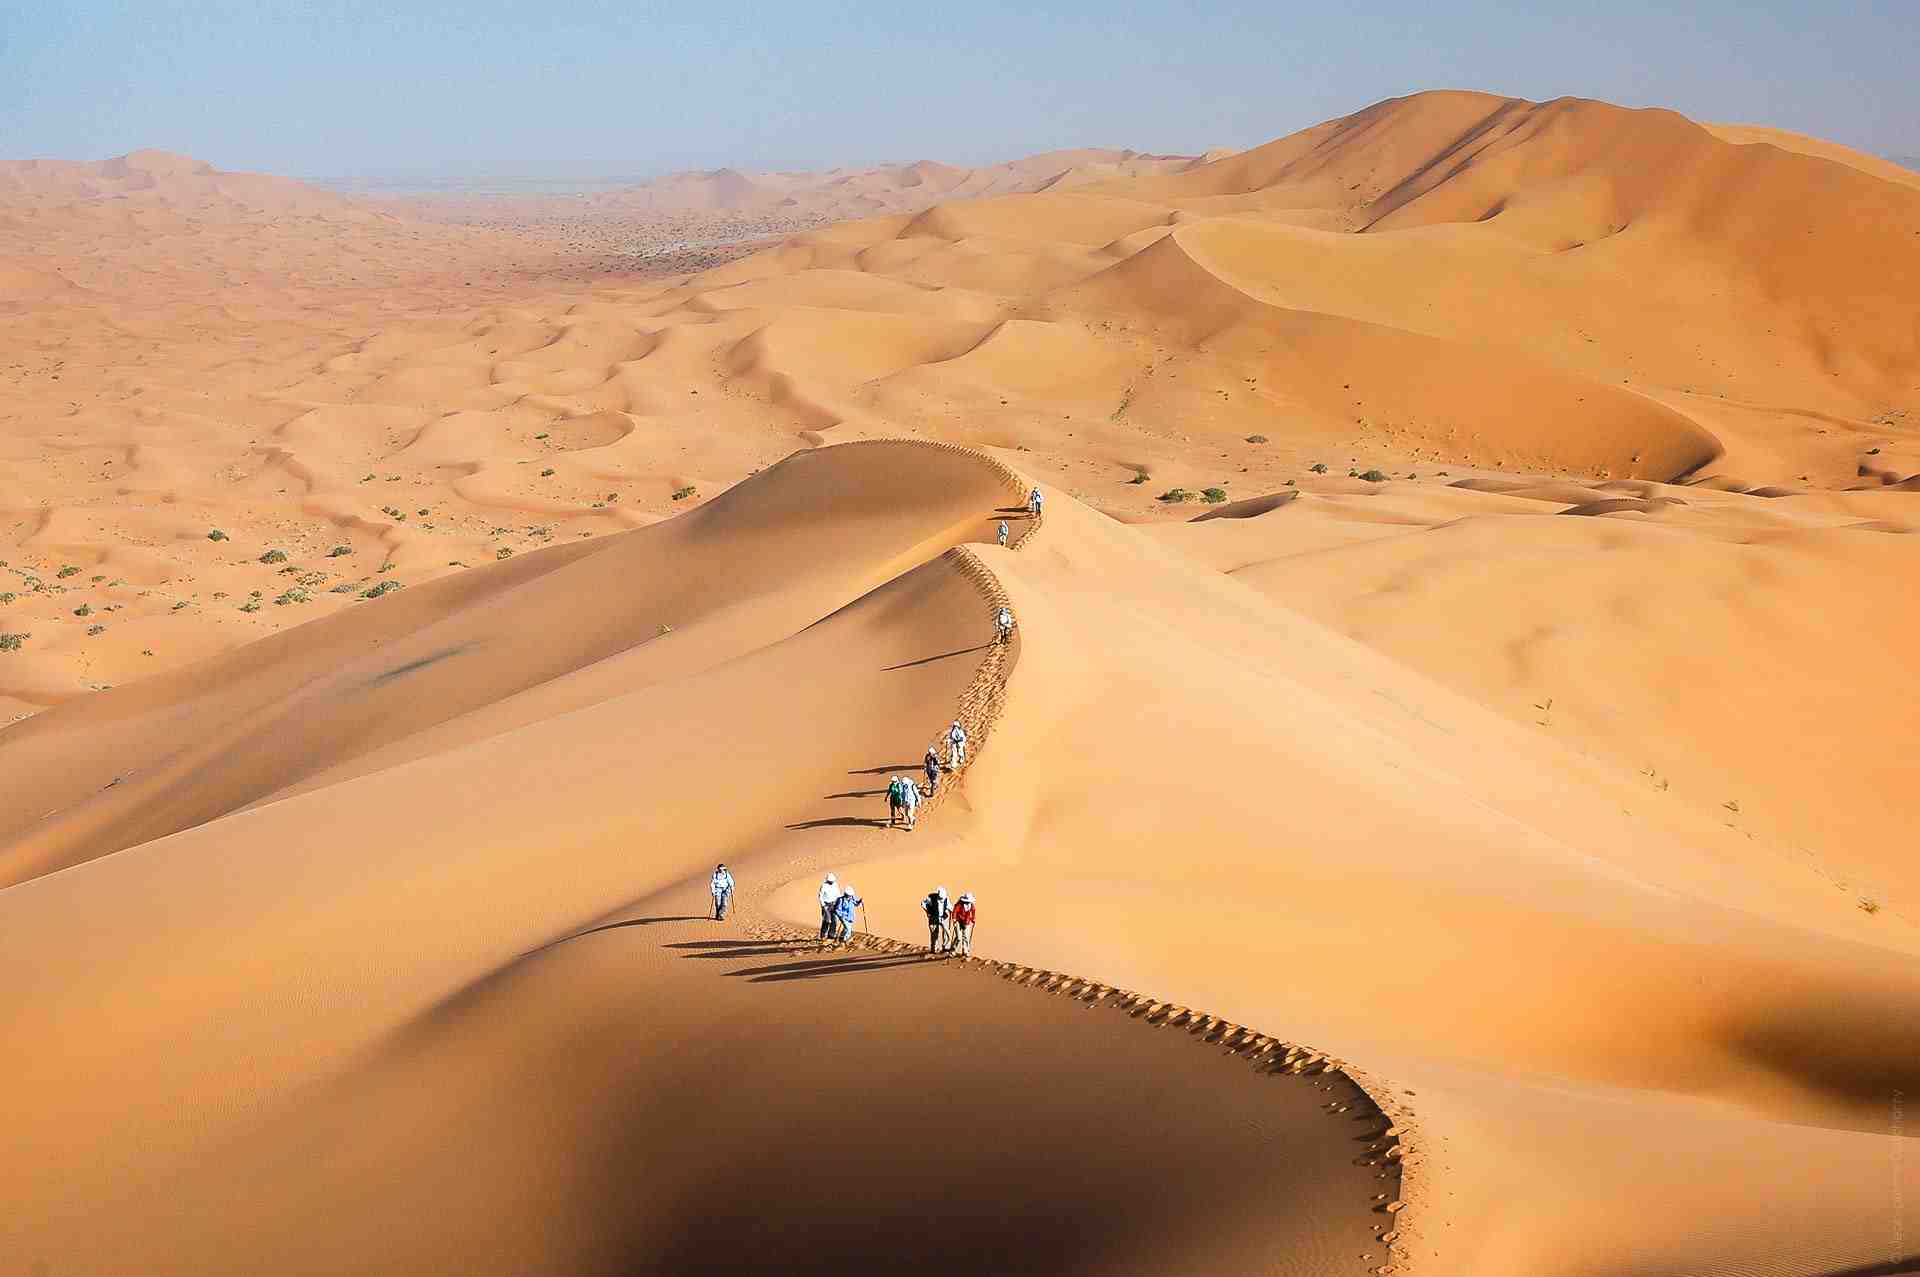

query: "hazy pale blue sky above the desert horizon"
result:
(0, 0), (1920, 177)
